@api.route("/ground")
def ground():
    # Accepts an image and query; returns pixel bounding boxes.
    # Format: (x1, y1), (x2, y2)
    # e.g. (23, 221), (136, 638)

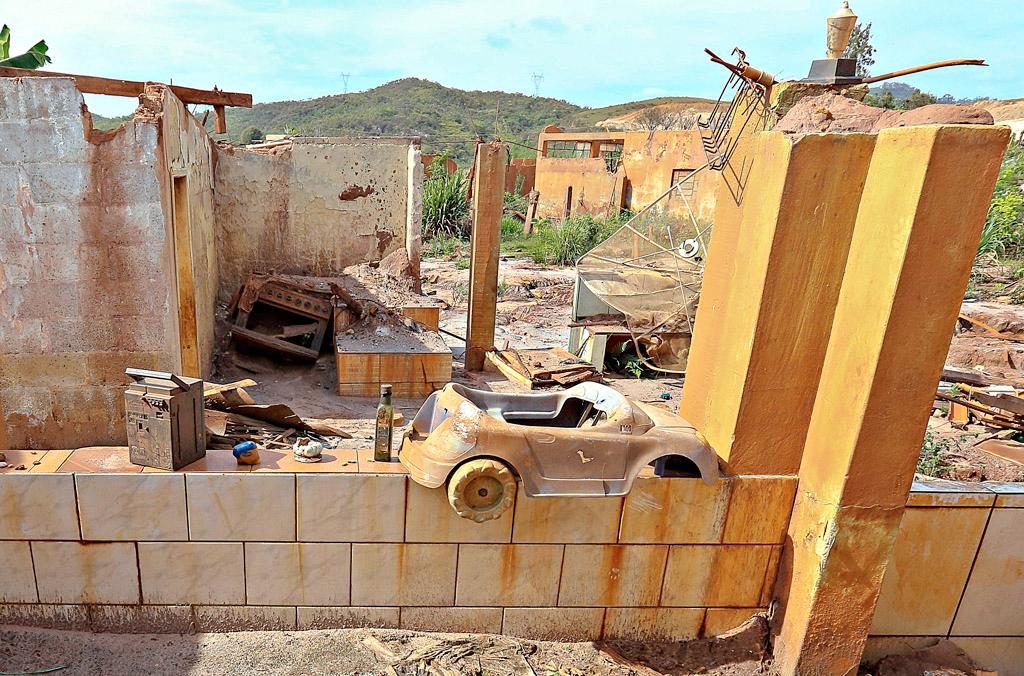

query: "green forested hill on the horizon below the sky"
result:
(93, 78), (705, 165)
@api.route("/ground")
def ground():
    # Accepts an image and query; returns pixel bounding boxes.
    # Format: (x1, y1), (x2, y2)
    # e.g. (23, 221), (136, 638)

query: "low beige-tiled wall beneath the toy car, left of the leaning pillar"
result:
(0, 472), (796, 639)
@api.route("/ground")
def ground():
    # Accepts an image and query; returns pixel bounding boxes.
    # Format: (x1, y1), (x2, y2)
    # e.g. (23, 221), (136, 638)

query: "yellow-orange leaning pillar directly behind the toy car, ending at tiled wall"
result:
(680, 132), (874, 474)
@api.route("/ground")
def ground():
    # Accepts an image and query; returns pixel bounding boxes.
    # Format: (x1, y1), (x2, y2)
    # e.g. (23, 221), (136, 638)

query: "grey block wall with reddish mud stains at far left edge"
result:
(0, 78), (180, 449)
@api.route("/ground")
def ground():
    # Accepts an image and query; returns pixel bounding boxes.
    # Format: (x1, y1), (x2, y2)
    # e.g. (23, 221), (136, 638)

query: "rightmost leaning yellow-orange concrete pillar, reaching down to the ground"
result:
(765, 125), (1009, 674)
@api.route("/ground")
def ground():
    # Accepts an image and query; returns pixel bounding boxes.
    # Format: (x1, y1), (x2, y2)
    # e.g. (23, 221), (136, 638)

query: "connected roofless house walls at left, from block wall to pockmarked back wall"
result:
(0, 77), (423, 449)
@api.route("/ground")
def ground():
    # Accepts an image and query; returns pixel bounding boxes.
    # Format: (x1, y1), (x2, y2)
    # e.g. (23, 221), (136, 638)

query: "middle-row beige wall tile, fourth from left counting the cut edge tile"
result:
(246, 542), (352, 605)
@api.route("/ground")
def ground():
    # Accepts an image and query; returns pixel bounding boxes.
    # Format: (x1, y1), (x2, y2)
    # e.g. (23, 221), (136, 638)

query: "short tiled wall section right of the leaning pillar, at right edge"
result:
(864, 481), (1024, 676)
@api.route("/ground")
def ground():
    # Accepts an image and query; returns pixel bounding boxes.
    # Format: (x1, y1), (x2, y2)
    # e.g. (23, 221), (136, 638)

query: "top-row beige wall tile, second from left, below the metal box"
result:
(75, 473), (188, 541)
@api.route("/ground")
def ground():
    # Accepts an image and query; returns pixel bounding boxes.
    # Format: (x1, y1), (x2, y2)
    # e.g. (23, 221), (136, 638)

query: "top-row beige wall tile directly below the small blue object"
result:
(185, 472), (295, 542)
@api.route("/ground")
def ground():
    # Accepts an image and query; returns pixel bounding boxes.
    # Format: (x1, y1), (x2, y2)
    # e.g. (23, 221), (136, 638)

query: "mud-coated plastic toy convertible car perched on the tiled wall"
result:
(398, 382), (719, 521)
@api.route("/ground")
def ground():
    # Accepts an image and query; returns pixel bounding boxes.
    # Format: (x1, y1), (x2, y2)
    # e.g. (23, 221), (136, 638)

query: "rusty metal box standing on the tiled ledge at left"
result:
(125, 369), (206, 470)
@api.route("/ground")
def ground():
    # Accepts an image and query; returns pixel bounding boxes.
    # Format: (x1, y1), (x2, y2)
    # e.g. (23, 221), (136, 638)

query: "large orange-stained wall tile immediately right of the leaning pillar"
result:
(870, 507), (988, 636)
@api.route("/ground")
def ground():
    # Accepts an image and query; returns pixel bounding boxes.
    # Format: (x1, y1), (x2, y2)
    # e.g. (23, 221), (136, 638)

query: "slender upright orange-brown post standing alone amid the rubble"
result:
(466, 143), (508, 371)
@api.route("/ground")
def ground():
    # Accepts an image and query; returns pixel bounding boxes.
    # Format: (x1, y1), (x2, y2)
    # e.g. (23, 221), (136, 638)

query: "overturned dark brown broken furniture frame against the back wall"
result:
(231, 276), (333, 362)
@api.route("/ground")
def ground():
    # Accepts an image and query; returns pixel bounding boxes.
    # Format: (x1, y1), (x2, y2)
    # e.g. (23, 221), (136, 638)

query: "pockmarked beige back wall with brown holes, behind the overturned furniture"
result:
(215, 138), (423, 295)
